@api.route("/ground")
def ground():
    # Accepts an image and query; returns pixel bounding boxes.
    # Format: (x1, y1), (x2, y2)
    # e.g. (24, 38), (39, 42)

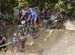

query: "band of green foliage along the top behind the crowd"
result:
(0, 0), (75, 17)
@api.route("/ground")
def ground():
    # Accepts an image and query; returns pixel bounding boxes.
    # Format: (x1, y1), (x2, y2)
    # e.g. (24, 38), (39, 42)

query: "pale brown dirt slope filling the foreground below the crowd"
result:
(0, 29), (75, 55)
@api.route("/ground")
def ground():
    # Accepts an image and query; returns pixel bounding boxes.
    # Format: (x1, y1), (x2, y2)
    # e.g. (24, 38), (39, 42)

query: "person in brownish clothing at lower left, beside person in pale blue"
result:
(18, 32), (27, 51)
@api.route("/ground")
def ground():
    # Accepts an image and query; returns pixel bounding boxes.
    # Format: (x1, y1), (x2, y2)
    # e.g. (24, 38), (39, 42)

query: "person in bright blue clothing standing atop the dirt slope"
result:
(28, 7), (38, 30)
